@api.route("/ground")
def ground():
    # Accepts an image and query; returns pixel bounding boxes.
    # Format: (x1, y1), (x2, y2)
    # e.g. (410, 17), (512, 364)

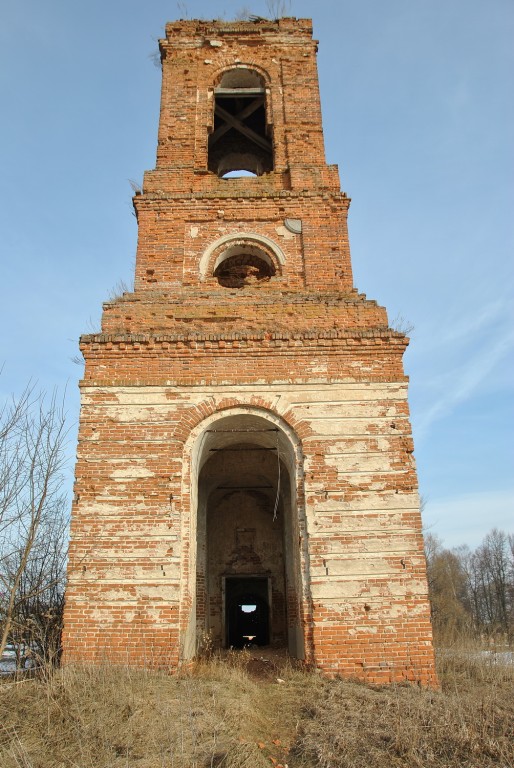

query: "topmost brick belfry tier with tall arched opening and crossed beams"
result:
(144, 19), (340, 192)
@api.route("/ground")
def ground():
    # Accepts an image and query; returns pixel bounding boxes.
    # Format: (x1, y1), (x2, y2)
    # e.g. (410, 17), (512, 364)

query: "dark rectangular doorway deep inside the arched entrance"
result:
(223, 576), (271, 648)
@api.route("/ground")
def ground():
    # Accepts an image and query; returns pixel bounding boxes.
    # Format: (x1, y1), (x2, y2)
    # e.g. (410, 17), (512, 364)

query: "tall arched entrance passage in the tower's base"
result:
(184, 408), (304, 658)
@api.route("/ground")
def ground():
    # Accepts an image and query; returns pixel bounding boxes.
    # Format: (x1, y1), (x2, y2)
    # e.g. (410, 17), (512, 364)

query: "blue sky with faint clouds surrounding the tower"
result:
(0, 0), (514, 547)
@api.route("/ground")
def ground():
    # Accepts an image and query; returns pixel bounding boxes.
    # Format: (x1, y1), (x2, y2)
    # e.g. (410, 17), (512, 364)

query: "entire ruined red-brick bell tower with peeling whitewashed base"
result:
(64, 19), (435, 684)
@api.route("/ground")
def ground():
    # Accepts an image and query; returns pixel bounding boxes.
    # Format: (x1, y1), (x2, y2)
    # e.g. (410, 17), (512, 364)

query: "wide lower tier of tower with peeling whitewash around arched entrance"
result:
(64, 333), (436, 685)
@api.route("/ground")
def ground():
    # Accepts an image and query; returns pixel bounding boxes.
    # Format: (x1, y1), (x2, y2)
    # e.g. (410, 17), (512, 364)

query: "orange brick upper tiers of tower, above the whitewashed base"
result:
(102, 19), (387, 334)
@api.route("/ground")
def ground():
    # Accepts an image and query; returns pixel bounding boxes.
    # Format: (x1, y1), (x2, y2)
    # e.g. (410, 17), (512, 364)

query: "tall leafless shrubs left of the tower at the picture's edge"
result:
(0, 386), (67, 666)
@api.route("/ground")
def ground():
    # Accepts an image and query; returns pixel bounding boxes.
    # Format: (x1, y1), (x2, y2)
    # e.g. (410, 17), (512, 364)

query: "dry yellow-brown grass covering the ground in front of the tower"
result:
(0, 652), (514, 768)
